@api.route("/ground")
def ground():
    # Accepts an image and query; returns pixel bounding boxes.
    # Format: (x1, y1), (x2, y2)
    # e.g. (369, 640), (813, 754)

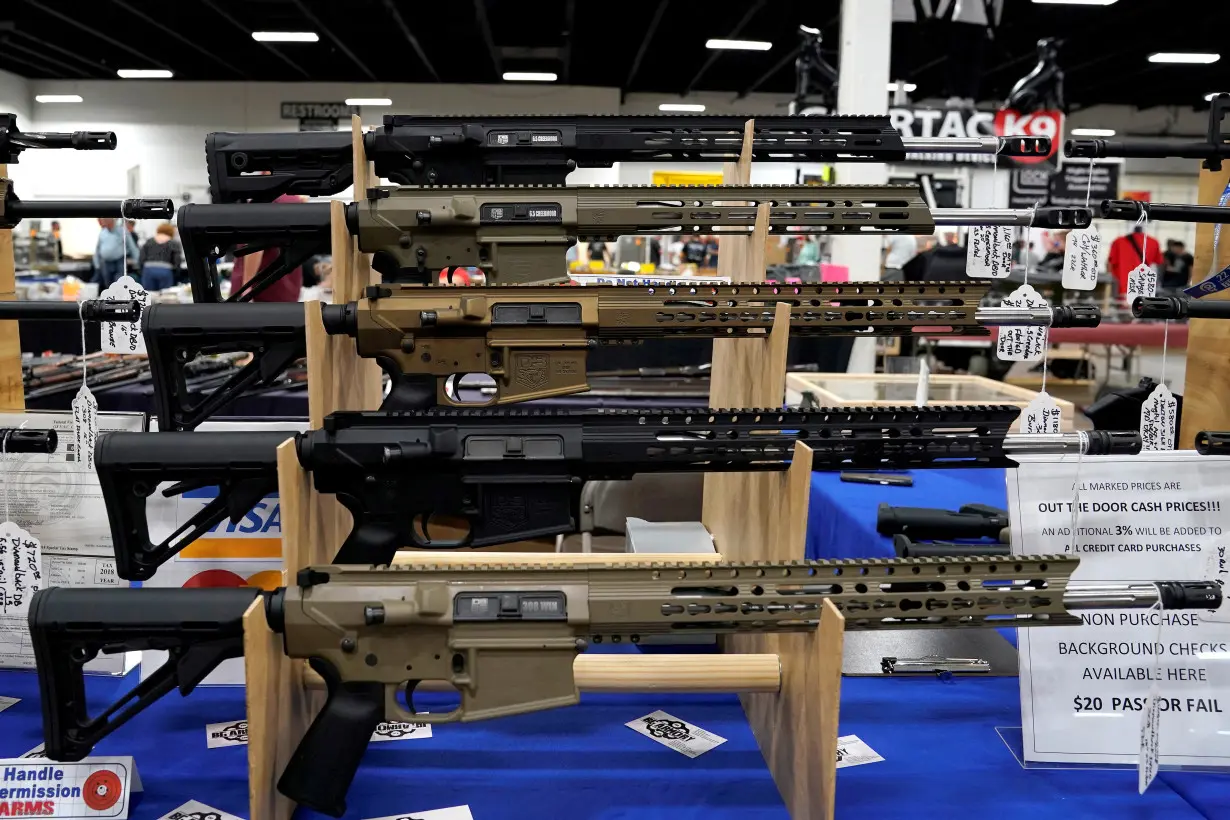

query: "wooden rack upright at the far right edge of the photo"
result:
(1175, 158), (1230, 442)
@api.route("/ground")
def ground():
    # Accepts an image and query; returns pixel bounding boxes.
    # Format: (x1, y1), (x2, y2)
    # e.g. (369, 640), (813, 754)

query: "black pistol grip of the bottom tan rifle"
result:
(278, 660), (384, 818)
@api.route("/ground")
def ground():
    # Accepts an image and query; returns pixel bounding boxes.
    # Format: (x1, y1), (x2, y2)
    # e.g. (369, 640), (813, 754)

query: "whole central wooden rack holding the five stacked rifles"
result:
(244, 117), (844, 820)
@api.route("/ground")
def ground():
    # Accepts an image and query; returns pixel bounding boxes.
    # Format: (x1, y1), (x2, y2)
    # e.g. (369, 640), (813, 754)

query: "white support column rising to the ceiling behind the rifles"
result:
(830, 0), (893, 373)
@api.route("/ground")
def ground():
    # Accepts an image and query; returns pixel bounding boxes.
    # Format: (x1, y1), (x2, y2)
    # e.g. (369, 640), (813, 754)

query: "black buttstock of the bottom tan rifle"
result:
(27, 586), (262, 761)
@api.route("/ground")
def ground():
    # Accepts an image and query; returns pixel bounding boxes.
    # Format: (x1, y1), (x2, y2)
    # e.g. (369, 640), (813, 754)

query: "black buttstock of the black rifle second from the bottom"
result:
(93, 430), (285, 580)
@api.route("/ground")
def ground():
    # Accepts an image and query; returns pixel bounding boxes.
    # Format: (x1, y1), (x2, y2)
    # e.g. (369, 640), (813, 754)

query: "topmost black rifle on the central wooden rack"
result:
(205, 114), (1050, 203)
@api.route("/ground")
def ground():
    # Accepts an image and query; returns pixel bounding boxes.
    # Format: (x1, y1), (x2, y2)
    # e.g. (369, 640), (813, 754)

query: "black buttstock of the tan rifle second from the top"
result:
(177, 202), (331, 302)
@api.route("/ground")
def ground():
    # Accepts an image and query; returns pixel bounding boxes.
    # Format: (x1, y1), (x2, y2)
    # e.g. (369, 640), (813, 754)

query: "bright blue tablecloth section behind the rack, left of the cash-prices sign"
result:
(807, 467), (1007, 558)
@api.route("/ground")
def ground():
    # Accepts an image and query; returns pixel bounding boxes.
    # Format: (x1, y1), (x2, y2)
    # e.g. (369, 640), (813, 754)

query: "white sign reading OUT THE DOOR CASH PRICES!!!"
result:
(1007, 450), (1230, 766)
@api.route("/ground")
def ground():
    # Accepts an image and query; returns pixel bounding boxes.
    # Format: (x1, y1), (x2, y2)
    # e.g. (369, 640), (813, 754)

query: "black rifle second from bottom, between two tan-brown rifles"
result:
(95, 407), (1140, 580)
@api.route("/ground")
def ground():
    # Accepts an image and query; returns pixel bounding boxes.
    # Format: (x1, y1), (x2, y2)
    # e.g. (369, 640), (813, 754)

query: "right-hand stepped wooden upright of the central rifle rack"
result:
(701, 122), (845, 820)
